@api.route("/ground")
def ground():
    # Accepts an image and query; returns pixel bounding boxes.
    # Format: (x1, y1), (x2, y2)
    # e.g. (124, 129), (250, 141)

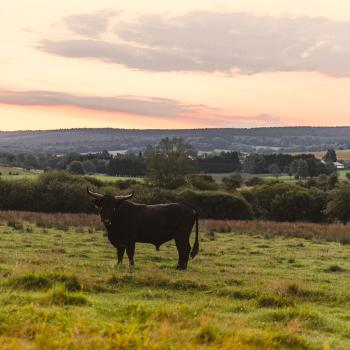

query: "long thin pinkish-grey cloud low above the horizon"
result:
(0, 90), (283, 127)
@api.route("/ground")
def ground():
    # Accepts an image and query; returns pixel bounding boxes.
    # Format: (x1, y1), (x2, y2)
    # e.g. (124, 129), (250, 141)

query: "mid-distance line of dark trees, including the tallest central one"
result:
(0, 137), (342, 180)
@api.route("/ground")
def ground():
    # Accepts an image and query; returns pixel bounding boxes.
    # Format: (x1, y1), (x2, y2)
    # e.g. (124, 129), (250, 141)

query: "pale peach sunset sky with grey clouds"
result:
(0, 0), (350, 130)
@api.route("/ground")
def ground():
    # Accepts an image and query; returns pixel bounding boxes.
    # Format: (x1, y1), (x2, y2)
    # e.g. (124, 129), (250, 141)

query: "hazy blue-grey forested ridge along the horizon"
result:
(0, 127), (350, 155)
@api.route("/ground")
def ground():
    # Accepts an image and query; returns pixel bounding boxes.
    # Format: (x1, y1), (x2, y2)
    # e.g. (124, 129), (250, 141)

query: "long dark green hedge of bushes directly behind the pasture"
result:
(0, 172), (350, 224)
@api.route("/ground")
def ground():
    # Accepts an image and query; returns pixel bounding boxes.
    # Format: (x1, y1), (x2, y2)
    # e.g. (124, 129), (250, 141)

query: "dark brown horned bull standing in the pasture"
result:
(87, 189), (199, 270)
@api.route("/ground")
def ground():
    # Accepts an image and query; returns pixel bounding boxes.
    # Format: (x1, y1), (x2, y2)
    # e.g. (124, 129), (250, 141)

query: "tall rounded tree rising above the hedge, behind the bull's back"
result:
(145, 137), (195, 188)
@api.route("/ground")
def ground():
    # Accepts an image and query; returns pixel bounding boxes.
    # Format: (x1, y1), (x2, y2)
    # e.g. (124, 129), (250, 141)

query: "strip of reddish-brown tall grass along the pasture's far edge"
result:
(0, 211), (350, 244)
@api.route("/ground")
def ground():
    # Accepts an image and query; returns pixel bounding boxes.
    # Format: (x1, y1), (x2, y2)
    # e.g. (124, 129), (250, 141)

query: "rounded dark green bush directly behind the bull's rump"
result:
(177, 190), (253, 220)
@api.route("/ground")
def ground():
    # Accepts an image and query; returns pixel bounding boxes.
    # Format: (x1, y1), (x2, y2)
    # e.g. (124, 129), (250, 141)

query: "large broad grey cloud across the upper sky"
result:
(39, 12), (350, 77)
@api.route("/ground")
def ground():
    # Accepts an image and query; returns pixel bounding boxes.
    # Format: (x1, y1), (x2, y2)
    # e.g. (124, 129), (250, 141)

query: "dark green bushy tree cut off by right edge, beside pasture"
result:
(326, 183), (350, 225)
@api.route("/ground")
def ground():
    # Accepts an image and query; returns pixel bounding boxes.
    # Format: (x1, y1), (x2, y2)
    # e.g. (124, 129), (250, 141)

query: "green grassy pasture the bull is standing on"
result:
(0, 212), (350, 350)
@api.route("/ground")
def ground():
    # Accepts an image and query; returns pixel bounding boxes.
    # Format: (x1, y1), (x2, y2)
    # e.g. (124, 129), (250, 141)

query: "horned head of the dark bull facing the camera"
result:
(87, 189), (134, 226)
